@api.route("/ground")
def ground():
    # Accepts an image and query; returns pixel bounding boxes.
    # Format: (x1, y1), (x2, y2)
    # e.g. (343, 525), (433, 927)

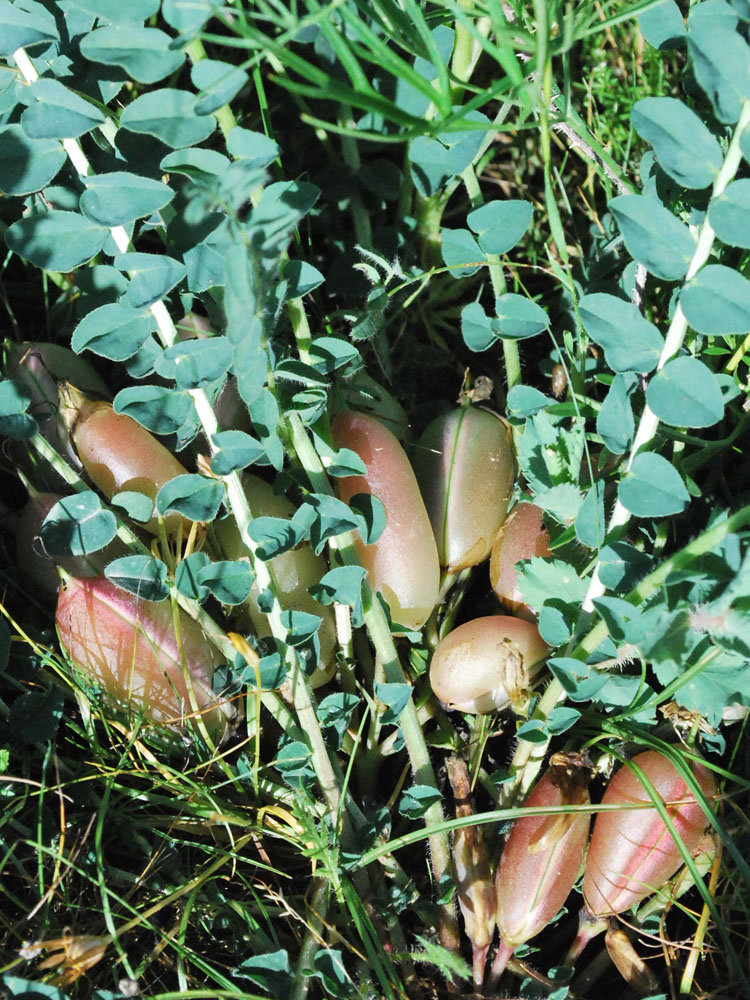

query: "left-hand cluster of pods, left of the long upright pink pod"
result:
(9, 344), (335, 740)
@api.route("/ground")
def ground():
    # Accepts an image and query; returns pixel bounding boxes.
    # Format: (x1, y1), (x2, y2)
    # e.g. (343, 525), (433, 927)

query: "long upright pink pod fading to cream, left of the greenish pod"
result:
(332, 410), (440, 628)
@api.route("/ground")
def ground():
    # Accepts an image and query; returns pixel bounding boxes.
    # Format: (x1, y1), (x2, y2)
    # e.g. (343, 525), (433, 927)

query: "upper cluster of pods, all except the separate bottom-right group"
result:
(7, 336), (548, 733)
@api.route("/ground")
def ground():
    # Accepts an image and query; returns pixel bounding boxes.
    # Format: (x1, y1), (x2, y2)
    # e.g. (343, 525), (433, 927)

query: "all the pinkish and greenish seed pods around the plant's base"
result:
(10, 345), (716, 987)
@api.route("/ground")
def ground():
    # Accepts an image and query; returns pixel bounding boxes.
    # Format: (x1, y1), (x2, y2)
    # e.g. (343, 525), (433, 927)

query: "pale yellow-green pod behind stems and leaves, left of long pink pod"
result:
(214, 474), (336, 687)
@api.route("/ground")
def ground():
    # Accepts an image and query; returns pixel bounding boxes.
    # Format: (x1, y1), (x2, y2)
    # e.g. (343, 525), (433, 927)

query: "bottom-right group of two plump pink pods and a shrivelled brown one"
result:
(453, 750), (717, 991)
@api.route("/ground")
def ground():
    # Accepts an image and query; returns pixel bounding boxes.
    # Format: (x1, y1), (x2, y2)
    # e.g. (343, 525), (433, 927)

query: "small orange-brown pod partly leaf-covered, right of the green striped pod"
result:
(490, 503), (550, 620)
